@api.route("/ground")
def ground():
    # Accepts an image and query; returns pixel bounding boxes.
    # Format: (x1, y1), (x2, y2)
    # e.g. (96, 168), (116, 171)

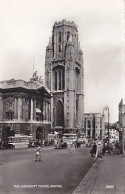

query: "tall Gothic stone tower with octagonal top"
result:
(45, 20), (84, 132)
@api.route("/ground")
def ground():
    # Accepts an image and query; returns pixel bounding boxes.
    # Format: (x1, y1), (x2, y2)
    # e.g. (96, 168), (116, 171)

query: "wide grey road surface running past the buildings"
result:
(0, 146), (93, 194)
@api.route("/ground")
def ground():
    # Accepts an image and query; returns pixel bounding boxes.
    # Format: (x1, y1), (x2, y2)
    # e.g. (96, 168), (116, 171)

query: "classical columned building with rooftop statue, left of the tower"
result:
(0, 77), (51, 140)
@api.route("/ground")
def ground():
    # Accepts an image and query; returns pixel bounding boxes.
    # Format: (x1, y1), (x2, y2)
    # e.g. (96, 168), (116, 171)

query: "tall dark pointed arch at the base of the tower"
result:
(56, 100), (64, 127)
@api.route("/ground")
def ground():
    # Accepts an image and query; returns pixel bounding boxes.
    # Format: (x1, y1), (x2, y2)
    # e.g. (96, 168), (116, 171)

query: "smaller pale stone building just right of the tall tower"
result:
(84, 113), (105, 139)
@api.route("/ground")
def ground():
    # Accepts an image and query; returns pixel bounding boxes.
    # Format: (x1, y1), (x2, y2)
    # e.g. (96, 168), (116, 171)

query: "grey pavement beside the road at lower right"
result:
(73, 155), (125, 194)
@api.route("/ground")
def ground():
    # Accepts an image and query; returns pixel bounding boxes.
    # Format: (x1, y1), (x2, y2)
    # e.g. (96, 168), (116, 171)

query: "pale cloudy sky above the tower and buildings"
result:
(0, 0), (125, 122)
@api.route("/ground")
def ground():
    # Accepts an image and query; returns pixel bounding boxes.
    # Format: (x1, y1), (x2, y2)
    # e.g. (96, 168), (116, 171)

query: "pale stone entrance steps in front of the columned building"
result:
(9, 134), (33, 148)
